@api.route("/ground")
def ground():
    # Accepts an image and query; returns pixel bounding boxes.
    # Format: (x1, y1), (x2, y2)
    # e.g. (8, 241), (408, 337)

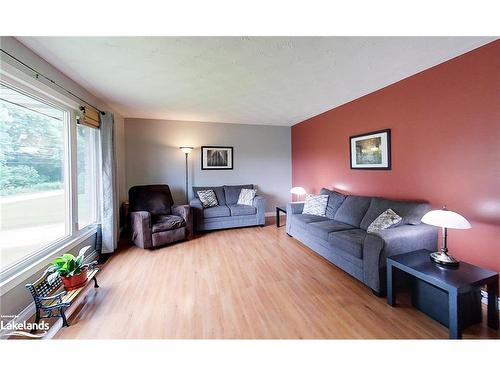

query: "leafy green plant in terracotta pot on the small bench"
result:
(47, 246), (95, 290)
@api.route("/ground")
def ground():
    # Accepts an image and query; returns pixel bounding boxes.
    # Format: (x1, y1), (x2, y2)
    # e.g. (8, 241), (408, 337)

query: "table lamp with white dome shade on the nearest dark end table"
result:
(422, 206), (471, 266)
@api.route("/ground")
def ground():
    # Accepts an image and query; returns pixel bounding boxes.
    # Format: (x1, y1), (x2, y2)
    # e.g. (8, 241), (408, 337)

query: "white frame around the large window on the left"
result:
(0, 64), (102, 290)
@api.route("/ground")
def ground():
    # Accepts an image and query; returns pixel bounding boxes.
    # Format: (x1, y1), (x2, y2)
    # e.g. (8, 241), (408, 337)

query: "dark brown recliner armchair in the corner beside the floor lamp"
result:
(128, 185), (193, 249)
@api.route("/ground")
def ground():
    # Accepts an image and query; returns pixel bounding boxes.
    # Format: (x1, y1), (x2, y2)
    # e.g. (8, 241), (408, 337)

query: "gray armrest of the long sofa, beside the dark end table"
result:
(363, 224), (438, 290)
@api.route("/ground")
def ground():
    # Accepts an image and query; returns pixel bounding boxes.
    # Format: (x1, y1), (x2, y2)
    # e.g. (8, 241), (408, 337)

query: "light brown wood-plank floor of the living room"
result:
(56, 223), (499, 339)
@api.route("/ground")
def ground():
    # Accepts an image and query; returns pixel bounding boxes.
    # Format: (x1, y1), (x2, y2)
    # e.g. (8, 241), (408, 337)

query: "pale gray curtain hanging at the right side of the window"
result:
(99, 112), (118, 254)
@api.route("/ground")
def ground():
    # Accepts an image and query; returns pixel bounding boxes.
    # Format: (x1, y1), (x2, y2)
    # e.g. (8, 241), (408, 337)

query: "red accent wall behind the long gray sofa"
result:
(292, 40), (500, 271)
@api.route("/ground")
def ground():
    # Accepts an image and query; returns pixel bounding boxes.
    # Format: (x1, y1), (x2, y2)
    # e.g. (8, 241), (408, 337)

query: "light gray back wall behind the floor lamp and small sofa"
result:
(125, 119), (291, 212)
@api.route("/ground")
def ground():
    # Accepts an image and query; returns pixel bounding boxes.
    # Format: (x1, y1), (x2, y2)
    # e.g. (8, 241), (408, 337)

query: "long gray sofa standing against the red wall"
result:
(286, 189), (438, 295)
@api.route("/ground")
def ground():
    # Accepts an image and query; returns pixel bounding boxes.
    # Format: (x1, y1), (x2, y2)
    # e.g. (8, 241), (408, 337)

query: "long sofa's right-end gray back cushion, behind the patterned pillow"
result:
(360, 197), (430, 229)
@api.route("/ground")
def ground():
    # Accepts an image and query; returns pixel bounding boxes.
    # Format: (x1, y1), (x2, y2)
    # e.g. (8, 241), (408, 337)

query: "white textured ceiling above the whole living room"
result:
(17, 37), (496, 126)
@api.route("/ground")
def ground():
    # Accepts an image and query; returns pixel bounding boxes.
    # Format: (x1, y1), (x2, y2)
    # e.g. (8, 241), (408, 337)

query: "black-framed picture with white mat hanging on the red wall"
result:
(349, 129), (391, 170)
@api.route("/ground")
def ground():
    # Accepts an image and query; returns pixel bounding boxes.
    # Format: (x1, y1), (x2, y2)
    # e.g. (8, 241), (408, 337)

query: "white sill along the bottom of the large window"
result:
(0, 225), (97, 296)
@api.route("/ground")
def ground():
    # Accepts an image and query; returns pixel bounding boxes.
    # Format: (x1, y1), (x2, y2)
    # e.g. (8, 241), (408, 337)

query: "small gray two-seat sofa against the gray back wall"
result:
(189, 185), (266, 231)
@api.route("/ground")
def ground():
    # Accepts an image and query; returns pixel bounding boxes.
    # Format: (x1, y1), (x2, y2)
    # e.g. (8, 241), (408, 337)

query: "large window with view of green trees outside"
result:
(0, 82), (98, 270)
